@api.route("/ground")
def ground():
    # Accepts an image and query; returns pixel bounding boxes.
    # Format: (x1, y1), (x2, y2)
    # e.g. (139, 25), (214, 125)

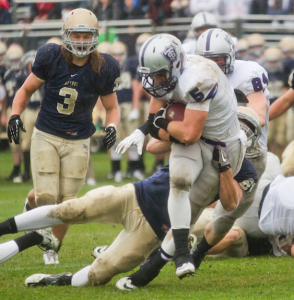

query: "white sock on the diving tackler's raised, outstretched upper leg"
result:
(14, 205), (64, 232)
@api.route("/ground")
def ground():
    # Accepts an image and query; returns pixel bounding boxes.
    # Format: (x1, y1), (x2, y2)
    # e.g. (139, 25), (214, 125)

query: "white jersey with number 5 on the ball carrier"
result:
(153, 55), (240, 143)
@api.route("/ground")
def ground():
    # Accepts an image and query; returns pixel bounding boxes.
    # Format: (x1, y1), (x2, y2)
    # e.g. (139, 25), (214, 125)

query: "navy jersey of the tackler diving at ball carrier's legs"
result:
(133, 157), (258, 240)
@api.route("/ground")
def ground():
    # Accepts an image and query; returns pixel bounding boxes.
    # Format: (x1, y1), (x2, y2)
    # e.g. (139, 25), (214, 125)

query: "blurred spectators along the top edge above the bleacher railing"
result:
(0, 0), (293, 25)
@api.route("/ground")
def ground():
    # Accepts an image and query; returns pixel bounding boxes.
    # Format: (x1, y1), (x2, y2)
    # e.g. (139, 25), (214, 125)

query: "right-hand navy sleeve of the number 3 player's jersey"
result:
(99, 55), (120, 96)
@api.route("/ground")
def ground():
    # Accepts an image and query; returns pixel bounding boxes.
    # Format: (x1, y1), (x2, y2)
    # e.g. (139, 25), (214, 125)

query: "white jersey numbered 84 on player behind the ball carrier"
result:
(227, 60), (270, 157)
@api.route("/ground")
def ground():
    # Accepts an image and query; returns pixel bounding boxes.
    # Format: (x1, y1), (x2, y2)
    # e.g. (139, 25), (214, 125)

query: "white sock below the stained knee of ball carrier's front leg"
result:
(168, 188), (191, 229)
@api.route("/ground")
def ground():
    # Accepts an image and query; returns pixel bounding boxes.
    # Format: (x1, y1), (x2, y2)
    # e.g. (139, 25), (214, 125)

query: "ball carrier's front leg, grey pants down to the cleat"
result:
(168, 143), (203, 278)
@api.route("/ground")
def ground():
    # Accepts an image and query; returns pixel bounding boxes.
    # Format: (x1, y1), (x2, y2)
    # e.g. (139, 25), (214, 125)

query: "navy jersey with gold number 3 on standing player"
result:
(32, 44), (120, 139)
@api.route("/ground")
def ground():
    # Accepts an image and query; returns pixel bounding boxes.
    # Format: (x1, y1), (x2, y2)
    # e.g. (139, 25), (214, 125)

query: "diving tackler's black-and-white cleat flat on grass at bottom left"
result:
(25, 273), (72, 287)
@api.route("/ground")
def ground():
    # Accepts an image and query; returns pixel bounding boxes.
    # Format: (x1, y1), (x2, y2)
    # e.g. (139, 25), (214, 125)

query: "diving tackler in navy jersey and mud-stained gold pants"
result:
(0, 143), (257, 286)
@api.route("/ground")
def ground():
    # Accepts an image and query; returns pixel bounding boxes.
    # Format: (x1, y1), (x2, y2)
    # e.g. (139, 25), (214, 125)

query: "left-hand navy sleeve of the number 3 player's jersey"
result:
(32, 44), (55, 81)
